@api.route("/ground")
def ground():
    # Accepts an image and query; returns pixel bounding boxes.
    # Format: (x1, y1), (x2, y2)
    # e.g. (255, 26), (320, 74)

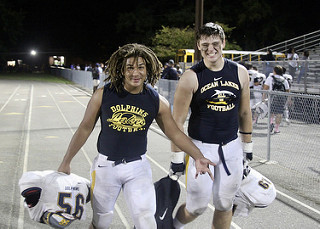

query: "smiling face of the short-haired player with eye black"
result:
(198, 35), (225, 63)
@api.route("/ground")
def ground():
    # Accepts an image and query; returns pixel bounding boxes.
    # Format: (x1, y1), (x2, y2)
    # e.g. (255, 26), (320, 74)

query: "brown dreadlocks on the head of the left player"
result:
(106, 43), (162, 92)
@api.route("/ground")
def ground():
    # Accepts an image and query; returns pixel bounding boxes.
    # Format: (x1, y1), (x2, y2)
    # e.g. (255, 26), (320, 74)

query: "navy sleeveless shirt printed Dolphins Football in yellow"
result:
(97, 83), (159, 160)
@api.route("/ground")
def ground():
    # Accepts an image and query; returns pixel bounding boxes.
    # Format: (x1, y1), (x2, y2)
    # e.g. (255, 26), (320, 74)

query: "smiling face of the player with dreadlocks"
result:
(124, 57), (147, 94)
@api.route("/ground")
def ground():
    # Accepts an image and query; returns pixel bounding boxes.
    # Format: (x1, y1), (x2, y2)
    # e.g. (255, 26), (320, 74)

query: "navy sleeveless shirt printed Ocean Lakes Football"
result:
(188, 59), (241, 144)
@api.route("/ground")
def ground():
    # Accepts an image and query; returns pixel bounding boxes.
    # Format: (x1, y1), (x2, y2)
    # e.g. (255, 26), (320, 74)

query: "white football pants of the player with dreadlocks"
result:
(91, 154), (157, 229)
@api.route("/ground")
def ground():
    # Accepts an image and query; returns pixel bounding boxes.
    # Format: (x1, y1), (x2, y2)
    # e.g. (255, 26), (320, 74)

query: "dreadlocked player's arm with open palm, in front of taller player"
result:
(156, 96), (215, 179)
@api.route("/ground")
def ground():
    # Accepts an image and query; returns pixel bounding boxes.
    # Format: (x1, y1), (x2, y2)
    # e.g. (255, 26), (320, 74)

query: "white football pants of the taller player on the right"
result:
(186, 138), (243, 215)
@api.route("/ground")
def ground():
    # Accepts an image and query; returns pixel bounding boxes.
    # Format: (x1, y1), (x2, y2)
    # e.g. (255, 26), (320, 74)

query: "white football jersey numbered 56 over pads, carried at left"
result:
(19, 170), (90, 222)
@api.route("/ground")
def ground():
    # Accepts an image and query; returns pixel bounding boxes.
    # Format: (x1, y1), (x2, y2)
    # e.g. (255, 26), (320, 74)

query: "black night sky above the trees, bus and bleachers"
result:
(5, 0), (319, 65)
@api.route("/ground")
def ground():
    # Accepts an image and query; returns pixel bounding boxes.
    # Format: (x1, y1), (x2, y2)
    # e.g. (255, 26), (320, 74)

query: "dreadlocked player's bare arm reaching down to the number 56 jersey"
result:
(58, 88), (103, 174)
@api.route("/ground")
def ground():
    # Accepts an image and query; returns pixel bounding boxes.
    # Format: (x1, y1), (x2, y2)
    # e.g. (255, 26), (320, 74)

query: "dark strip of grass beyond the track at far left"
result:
(0, 73), (73, 84)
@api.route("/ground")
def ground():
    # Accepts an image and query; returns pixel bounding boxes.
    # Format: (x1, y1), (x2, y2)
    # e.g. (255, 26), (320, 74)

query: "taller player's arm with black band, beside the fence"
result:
(238, 65), (253, 160)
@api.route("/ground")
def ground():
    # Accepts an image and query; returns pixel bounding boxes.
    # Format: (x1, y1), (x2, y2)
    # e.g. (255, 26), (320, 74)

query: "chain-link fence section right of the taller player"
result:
(252, 90), (320, 204)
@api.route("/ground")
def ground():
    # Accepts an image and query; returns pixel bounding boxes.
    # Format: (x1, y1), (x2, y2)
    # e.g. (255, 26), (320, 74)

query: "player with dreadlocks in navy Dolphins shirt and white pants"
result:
(58, 44), (214, 229)
